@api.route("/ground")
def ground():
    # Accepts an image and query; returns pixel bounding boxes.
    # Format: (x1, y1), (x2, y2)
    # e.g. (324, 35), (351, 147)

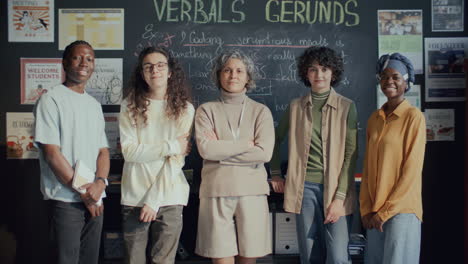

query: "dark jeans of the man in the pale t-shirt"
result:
(48, 200), (103, 264)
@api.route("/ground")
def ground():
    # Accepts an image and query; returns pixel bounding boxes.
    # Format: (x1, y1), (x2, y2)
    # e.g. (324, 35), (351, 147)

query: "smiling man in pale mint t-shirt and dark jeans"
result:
(34, 41), (109, 264)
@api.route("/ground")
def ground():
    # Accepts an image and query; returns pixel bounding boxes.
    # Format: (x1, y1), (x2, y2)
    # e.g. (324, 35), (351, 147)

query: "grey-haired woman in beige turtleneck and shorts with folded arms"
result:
(195, 50), (275, 264)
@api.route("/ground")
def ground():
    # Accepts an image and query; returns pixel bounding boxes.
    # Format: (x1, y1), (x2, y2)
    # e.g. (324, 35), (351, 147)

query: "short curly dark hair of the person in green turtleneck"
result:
(297, 46), (344, 87)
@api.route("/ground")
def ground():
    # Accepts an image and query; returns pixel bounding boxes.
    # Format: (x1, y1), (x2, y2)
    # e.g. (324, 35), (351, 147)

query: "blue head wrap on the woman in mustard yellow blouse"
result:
(376, 53), (414, 92)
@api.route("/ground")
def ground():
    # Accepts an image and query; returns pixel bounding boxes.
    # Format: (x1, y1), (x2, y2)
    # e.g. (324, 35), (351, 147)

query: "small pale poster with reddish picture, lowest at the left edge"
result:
(6, 113), (39, 159)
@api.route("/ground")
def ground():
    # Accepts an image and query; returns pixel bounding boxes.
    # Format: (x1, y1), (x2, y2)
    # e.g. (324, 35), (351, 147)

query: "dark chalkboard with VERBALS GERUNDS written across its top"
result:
(126, 0), (377, 172)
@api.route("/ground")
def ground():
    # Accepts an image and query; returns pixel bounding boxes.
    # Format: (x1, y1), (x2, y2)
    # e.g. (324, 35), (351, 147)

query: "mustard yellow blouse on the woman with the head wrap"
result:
(360, 100), (426, 221)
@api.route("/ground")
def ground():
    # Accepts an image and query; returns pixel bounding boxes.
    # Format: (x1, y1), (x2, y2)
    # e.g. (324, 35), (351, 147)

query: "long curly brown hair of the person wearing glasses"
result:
(123, 46), (190, 126)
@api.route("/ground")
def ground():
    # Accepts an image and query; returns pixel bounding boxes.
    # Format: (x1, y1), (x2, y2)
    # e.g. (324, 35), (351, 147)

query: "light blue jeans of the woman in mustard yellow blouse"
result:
(364, 214), (421, 264)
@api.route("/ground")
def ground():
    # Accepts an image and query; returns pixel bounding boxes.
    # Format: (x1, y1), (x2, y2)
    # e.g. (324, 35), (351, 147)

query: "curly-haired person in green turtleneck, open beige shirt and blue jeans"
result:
(270, 47), (357, 264)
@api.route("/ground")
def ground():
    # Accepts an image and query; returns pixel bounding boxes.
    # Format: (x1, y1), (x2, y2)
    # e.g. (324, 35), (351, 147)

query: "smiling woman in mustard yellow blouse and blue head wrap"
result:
(360, 53), (426, 264)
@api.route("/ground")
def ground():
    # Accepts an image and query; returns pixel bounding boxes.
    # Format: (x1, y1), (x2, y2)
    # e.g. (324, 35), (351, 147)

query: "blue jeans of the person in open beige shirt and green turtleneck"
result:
(296, 181), (350, 264)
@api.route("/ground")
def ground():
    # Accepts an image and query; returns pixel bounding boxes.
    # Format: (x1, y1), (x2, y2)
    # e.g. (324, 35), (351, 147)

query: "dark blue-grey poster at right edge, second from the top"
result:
(424, 38), (468, 102)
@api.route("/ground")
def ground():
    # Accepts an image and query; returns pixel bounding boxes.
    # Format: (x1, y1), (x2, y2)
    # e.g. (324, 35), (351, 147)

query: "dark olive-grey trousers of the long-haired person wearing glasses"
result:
(122, 205), (183, 264)
